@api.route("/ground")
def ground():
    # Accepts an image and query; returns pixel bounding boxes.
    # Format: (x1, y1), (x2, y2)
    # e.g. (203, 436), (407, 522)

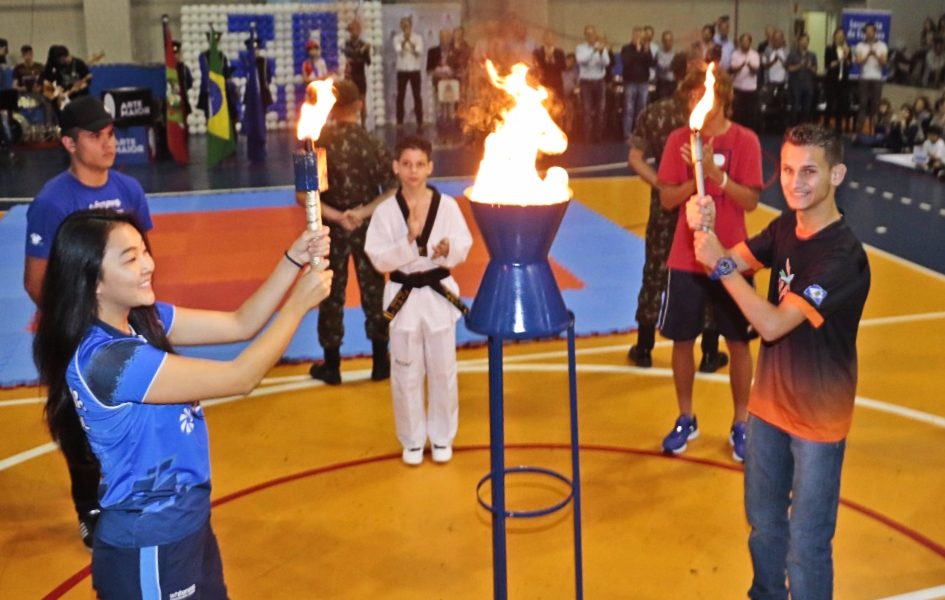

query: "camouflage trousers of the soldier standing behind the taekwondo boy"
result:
(318, 223), (390, 348)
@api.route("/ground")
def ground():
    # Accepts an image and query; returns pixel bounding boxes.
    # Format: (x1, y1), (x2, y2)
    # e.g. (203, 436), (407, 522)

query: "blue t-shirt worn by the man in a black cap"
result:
(26, 170), (153, 258)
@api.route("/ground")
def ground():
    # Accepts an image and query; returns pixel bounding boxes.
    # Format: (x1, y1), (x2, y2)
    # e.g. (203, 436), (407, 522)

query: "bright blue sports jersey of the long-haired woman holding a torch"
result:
(66, 303), (210, 547)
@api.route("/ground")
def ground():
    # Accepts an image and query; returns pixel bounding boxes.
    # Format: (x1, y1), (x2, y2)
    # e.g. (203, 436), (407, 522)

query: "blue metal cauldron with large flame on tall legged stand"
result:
(466, 61), (583, 600)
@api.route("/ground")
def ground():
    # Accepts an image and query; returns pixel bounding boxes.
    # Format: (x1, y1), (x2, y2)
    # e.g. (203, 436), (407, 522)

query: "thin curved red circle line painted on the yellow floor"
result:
(43, 444), (945, 600)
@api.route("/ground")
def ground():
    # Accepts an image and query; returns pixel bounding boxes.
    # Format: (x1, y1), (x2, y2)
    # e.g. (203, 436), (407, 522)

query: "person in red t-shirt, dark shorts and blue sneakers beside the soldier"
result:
(658, 64), (762, 462)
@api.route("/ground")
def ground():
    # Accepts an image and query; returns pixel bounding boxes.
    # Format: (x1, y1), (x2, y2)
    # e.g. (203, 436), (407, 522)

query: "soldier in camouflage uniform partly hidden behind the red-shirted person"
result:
(627, 54), (728, 373)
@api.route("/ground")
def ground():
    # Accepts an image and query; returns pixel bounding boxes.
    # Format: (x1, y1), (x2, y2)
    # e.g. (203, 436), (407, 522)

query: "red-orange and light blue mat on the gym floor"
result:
(0, 181), (643, 387)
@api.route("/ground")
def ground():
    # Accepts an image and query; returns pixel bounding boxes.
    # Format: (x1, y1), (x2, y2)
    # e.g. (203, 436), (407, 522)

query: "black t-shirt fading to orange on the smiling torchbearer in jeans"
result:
(742, 212), (870, 442)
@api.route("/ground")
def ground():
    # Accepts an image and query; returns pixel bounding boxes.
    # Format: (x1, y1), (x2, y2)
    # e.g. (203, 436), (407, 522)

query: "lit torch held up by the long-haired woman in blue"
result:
(292, 79), (335, 269)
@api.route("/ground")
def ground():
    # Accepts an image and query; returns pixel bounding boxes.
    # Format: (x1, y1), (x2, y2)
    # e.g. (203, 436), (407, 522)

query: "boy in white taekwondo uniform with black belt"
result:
(364, 136), (472, 465)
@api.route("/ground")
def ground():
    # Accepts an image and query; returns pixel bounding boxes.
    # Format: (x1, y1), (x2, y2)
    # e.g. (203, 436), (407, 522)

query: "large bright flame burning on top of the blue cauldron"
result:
(467, 60), (571, 205)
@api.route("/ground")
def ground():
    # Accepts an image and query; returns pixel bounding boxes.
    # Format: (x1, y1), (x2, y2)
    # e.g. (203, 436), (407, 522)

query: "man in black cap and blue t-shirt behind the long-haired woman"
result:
(23, 96), (152, 549)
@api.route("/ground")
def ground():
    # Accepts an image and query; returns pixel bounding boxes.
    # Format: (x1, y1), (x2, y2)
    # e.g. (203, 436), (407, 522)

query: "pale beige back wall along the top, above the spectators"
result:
(0, 0), (945, 63)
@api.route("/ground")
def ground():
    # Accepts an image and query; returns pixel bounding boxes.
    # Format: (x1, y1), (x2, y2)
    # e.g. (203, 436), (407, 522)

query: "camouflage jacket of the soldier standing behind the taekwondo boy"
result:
(317, 123), (397, 210)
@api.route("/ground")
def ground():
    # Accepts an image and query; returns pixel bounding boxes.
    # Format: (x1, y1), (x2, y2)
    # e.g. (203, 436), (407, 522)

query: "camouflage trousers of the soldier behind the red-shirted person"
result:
(636, 188), (679, 327)
